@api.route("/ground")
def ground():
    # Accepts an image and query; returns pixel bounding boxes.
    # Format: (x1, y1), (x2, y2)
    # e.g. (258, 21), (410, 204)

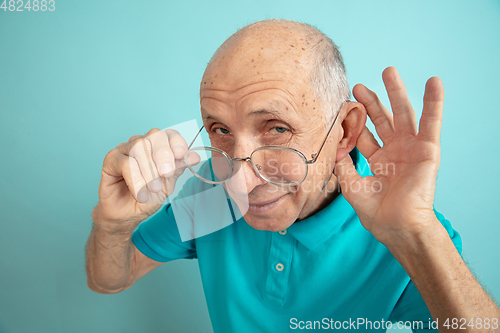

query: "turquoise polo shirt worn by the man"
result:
(132, 149), (462, 333)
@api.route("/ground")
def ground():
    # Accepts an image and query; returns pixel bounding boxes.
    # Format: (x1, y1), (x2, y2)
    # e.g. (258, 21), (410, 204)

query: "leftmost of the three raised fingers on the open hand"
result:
(352, 84), (394, 143)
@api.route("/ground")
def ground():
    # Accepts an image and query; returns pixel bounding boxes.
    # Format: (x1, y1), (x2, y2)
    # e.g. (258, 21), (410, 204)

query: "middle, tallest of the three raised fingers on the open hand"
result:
(382, 67), (417, 135)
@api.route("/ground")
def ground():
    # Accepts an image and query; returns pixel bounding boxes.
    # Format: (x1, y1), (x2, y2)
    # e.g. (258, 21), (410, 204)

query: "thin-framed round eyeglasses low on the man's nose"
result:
(184, 105), (340, 187)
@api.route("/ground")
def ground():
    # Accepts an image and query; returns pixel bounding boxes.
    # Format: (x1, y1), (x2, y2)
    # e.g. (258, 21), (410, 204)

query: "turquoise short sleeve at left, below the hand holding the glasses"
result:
(132, 203), (196, 262)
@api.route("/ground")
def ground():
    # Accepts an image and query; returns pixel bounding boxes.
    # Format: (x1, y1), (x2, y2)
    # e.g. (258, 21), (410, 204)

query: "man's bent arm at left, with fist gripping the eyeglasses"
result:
(86, 129), (192, 293)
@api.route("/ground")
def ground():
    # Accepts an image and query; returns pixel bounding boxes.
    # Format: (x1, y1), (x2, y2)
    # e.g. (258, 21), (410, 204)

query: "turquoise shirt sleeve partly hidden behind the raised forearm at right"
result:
(389, 209), (462, 332)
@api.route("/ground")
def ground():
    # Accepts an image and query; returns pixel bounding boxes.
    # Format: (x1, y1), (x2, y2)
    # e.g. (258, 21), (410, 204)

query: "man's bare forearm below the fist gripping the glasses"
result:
(86, 210), (136, 293)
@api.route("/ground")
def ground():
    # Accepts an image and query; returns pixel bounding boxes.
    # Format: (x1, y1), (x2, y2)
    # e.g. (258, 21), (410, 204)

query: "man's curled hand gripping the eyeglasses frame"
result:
(92, 129), (198, 225)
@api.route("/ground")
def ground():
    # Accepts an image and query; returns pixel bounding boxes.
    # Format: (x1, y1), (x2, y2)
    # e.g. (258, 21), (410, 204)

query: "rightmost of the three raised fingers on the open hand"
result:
(418, 77), (444, 143)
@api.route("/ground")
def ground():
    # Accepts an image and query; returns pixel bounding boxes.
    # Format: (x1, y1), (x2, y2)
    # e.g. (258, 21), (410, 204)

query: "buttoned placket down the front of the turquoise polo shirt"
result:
(264, 230), (295, 305)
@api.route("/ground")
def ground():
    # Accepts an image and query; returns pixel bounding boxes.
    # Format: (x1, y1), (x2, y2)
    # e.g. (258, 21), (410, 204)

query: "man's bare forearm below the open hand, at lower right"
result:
(388, 220), (500, 332)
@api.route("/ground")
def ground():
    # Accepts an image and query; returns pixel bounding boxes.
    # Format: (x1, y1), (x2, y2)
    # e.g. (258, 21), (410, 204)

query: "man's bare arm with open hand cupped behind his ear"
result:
(336, 67), (500, 332)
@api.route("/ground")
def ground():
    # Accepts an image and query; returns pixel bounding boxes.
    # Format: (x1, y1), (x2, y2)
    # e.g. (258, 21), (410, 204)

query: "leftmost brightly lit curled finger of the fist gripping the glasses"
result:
(129, 138), (163, 192)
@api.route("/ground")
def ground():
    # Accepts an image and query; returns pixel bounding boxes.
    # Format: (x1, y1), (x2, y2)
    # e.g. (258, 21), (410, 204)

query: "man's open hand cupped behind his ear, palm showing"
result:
(335, 67), (444, 245)
